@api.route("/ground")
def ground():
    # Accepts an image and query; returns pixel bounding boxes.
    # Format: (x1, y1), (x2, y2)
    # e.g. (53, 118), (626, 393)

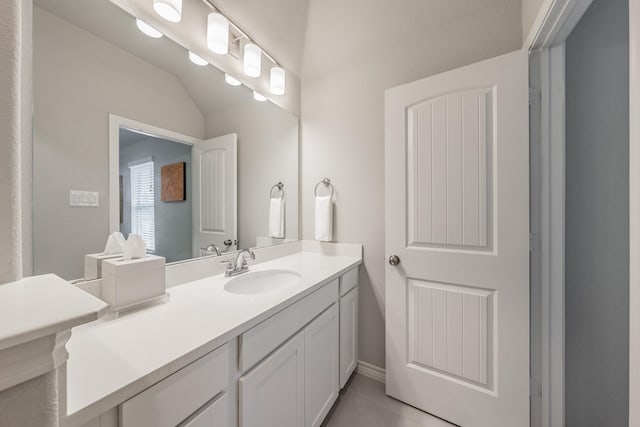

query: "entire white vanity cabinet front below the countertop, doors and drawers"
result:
(74, 267), (358, 427)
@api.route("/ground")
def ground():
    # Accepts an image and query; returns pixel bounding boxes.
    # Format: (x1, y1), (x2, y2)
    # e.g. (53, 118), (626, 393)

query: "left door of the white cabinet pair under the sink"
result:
(239, 331), (305, 427)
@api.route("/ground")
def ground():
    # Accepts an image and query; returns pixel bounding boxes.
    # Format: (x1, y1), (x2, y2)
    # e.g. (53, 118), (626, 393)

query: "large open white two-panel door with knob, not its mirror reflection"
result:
(385, 51), (529, 427)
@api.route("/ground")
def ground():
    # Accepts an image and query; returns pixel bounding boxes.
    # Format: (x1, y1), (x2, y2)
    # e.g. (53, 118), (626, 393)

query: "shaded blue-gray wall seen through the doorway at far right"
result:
(565, 0), (629, 427)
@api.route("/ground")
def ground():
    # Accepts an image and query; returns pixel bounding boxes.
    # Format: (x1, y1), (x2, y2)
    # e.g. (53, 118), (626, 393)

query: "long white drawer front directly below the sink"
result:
(239, 279), (339, 373)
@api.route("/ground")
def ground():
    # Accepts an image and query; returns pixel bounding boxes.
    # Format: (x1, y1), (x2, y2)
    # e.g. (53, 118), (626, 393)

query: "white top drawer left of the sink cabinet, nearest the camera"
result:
(120, 344), (231, 427)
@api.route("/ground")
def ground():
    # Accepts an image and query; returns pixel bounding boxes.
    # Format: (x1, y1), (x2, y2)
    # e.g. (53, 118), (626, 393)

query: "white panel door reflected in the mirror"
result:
(192, 133), (238, 257)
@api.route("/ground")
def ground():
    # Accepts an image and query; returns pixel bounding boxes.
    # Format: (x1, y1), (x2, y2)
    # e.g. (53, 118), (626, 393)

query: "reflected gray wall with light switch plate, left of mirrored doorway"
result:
(33, 7), (205, 279)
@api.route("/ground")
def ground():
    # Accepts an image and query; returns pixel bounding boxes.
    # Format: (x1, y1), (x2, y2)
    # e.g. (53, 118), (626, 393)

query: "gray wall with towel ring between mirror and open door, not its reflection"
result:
(300, 0), (522, 367)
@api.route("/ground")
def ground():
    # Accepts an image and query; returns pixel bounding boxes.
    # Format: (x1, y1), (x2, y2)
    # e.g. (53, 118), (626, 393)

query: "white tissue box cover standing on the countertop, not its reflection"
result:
(102, 255), (166, 311)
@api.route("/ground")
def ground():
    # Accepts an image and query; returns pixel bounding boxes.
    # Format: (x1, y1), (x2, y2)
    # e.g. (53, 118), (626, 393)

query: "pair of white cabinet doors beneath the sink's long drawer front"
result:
(239, 302), (339, 427)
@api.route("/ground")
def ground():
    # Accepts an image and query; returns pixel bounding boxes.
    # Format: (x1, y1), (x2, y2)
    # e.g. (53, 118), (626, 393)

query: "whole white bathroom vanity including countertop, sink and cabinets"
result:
(67, 242), (362, 427)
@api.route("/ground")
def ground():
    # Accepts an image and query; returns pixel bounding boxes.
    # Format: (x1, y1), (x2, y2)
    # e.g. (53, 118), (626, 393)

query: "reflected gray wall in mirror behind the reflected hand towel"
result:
(207, 95), (299, 248)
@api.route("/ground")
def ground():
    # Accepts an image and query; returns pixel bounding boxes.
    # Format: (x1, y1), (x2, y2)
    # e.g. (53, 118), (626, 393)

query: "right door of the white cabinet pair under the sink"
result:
(304, 304), (340, 427)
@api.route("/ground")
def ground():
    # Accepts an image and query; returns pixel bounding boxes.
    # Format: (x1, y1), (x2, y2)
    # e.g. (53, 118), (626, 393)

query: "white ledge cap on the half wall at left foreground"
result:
(0, 274), (107, 350)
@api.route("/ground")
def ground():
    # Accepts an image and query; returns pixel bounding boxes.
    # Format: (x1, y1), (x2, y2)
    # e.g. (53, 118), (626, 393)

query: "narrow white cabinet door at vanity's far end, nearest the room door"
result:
(340, 286), (358, 389)
